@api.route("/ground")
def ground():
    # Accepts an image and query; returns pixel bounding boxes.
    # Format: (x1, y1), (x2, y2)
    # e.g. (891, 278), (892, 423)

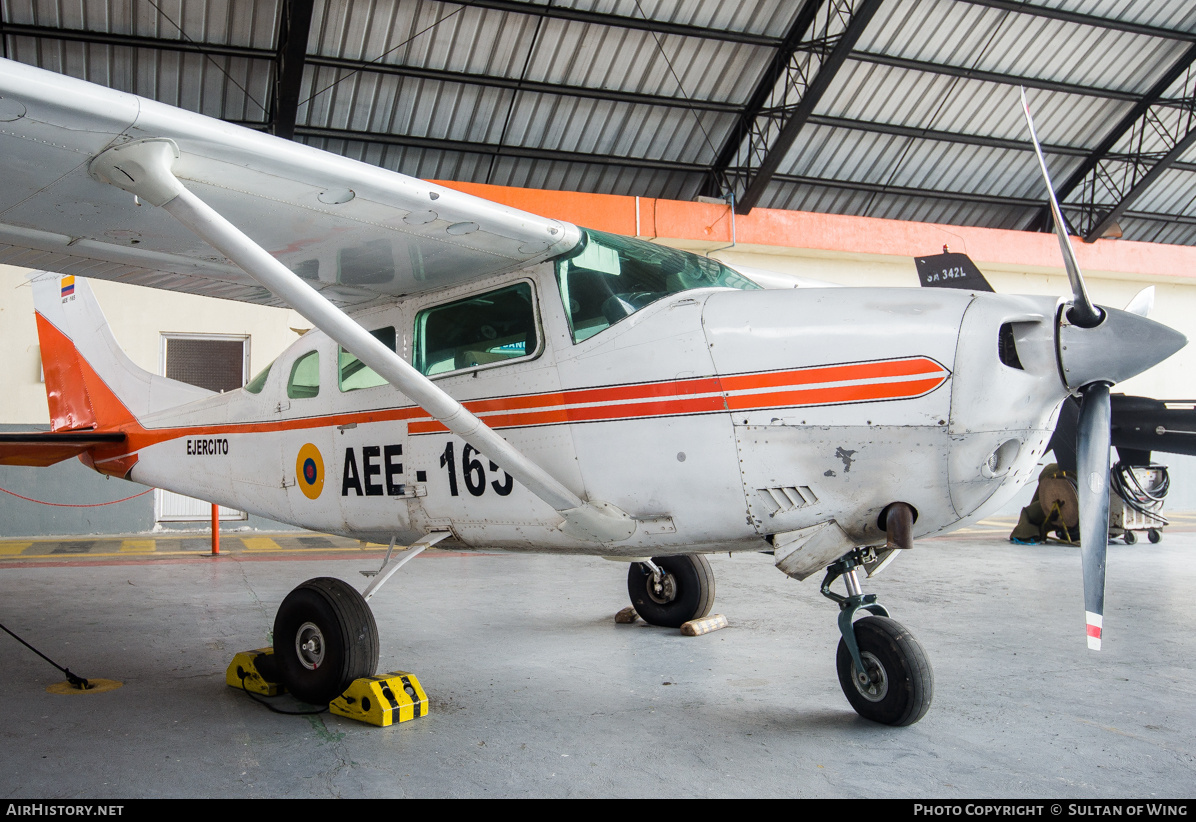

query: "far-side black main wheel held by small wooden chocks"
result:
(627, 554), (714, 628)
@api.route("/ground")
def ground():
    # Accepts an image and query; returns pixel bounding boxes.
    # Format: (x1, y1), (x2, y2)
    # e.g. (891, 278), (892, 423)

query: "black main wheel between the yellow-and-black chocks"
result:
(274, 577), (378, 705)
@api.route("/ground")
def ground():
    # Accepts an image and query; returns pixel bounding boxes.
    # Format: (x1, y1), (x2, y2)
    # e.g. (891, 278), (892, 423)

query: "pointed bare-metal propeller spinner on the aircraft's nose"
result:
(1056, 305), (1188, 390)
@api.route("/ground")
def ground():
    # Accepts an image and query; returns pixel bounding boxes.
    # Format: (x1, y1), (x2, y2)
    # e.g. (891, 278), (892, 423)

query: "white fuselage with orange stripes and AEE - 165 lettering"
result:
(36, 248), (1064, 559)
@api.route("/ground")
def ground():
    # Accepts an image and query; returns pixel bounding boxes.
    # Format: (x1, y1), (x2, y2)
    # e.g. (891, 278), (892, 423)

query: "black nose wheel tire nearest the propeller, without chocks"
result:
(835, 616), (934, 725)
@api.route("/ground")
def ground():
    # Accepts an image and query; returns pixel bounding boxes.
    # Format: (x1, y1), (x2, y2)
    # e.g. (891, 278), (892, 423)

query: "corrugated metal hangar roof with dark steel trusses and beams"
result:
(7, 0), (1196, 244)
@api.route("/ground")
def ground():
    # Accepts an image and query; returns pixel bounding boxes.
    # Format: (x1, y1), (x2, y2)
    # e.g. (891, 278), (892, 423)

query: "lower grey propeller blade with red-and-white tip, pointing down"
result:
(1075, 383), (1111, 651)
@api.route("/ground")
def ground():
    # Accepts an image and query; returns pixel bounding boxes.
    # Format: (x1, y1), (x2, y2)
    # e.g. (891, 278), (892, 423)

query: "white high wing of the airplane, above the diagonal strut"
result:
(0, 60), (579, 306)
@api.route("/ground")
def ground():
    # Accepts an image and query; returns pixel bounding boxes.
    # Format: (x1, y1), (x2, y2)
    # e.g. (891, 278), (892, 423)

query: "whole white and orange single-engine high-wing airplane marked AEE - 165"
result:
(0, 61), (1185, 725)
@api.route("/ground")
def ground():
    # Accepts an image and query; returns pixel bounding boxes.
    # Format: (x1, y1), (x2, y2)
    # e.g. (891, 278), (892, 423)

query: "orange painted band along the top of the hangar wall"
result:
(439, 182), (1196, 282)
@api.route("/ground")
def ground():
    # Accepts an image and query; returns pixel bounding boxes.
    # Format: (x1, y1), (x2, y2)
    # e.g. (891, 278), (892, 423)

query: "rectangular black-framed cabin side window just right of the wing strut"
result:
(414, 282), (539, 377)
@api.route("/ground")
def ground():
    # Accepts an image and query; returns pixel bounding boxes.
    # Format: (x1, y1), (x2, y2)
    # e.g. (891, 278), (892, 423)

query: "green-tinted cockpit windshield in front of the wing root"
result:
(556, 229), (759, 342)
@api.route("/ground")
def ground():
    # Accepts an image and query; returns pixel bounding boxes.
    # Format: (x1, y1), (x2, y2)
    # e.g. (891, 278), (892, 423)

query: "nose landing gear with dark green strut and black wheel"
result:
(820, 549), (934, 725)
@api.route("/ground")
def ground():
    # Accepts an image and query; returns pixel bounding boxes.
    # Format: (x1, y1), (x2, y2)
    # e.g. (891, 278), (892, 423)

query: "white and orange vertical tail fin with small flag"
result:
(32, 272), (212, 431)
